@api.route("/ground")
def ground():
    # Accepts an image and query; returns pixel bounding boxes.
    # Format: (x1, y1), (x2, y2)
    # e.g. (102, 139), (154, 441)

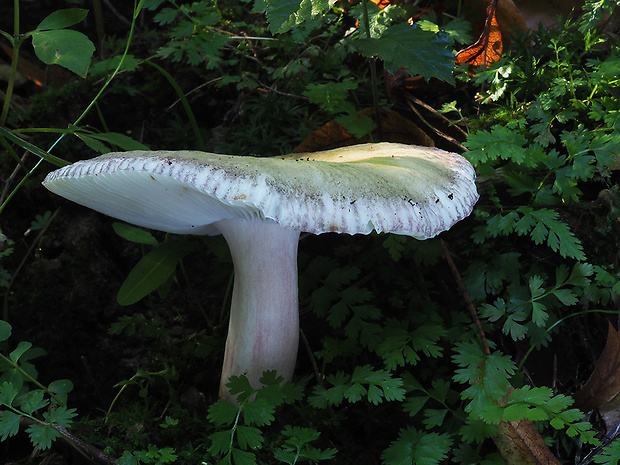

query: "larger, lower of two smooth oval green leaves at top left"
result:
(32, 29), (95, 77)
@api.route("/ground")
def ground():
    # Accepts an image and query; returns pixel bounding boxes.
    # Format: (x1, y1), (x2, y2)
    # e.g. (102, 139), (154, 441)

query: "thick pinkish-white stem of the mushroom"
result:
(215, 218), (299, 403)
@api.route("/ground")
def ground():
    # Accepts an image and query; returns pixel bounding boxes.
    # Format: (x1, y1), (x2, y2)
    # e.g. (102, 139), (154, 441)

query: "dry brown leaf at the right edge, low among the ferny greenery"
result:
(573, 323), (620, 412)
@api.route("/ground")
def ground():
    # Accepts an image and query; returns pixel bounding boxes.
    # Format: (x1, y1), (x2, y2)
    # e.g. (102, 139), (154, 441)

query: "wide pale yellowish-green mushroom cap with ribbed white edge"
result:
(43, 143), (478, 239)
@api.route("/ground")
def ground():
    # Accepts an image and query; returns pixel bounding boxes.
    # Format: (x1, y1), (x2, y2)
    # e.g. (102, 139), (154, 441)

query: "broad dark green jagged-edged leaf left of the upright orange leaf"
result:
(354, 23), (454, 84)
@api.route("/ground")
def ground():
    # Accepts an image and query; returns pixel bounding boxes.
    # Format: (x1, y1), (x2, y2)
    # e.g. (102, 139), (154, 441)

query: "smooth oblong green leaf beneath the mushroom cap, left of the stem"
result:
(117, 237), (191, 305)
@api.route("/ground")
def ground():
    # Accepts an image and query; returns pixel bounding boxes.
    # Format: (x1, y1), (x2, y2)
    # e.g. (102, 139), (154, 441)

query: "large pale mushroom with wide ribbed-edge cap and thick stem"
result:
(43, 143), (478, 402)
